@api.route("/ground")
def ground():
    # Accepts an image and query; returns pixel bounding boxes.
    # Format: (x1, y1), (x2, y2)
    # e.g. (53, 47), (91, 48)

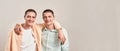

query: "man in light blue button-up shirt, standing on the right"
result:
(41, 9), (69, 51)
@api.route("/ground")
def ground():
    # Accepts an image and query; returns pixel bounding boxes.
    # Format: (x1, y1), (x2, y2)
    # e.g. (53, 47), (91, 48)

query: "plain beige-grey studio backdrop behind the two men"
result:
(0, 0), (120, 51)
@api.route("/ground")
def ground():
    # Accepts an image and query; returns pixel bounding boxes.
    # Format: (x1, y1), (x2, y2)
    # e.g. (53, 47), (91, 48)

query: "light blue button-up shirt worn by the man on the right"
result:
(41, 28), (69, 51)
